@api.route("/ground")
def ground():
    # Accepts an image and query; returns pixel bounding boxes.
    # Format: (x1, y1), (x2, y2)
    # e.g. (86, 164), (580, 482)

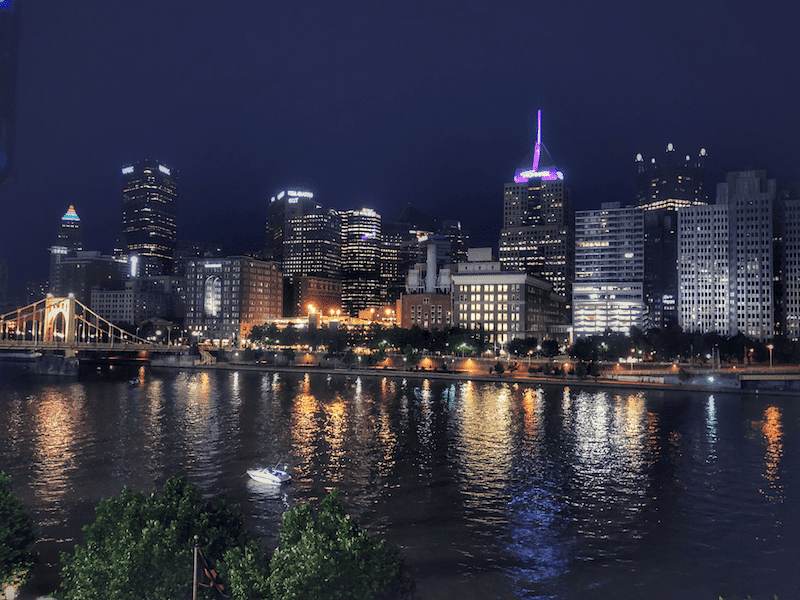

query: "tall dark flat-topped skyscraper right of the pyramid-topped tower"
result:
(122, 160), (178, 276)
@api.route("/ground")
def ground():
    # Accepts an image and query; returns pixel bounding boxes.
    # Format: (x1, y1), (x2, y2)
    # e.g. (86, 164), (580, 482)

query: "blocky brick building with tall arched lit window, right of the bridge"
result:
(185, 256), (283, 346)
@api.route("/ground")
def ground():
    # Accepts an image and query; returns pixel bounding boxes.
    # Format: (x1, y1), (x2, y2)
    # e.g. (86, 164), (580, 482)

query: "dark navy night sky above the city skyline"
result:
(0, 0), (800, 290)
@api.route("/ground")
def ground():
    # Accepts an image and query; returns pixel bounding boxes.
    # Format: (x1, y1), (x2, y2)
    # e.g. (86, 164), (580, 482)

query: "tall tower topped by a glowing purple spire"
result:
(499, 111), (575, 298)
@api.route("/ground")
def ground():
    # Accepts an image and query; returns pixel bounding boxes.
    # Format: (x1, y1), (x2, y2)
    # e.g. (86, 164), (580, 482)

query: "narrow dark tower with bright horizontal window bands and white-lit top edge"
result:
(339, 208), (383, 317)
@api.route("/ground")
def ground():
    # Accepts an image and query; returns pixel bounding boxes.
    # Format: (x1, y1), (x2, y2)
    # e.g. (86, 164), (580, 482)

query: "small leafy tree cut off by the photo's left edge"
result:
(0, 472), (36, 590)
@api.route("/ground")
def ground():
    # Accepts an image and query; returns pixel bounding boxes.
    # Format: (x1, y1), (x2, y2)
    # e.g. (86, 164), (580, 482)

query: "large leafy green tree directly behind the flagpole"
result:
(60, 477), (252, 600)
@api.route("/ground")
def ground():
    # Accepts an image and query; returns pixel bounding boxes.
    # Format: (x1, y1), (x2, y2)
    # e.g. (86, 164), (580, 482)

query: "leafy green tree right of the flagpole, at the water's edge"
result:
(269, 490), (413, 600)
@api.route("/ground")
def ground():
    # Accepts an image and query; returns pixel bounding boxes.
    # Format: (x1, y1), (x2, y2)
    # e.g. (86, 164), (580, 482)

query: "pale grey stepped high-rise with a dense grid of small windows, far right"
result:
(678, 171), (777, 341)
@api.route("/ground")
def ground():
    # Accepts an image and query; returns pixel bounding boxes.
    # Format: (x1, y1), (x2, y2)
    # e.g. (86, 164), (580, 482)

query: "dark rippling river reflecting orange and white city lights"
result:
(0, 365), (800, 600)
